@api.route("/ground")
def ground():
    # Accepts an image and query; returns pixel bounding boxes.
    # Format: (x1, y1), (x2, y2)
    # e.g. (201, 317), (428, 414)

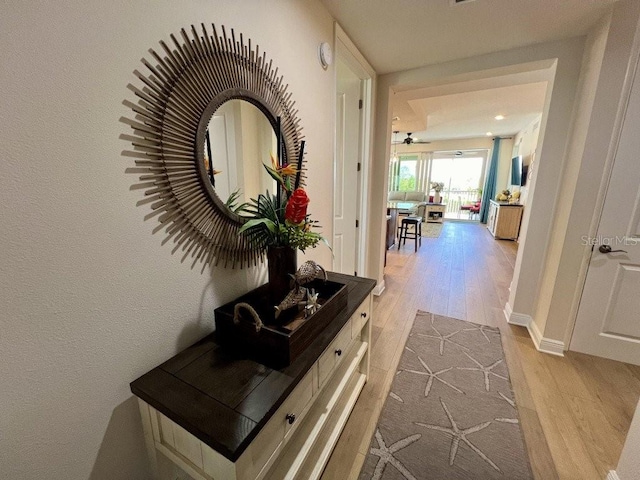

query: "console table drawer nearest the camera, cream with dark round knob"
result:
(251, 370), (313, 472)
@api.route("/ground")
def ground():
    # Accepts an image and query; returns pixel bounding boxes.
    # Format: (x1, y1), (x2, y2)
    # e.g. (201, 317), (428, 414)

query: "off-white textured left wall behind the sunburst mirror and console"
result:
(0, 0), (334, 480)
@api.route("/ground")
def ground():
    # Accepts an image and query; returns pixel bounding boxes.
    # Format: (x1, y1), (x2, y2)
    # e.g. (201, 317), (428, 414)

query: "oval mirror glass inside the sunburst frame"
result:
(203, 99), (277, 215)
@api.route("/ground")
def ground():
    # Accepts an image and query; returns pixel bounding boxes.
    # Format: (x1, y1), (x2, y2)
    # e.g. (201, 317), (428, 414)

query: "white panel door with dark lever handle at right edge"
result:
(570, 47), (640, 365)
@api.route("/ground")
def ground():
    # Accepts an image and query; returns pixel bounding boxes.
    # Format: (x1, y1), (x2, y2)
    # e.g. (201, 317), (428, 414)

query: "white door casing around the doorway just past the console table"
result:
(333, 22), (376, 276)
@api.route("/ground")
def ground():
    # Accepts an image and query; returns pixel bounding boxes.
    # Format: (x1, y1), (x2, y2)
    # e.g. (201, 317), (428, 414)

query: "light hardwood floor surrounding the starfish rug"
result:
(322, 222), (640, 480)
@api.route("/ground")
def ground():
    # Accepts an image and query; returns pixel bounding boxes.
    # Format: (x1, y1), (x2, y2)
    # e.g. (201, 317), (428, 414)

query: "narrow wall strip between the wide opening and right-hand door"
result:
(536, 0), (640, 345)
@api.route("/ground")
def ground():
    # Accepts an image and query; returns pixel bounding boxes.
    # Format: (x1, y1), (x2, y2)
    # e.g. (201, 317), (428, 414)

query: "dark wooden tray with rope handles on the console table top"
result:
(214, 280), (347, 369)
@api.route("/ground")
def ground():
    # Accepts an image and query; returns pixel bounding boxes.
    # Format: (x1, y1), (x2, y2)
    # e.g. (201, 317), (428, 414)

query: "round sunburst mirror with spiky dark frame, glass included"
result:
(122, 24), (304, 269)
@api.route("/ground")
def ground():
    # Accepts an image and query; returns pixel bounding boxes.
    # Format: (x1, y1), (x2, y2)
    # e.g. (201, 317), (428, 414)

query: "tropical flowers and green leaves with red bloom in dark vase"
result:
(240, 153), (328, 252)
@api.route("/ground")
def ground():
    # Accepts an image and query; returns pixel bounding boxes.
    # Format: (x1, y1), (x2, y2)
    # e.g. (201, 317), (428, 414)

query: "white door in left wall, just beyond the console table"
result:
(333, 58), (361, 274)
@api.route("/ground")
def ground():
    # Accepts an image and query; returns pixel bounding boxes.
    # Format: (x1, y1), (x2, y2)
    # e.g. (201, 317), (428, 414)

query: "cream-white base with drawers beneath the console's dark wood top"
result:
(139, 294), (372, 480)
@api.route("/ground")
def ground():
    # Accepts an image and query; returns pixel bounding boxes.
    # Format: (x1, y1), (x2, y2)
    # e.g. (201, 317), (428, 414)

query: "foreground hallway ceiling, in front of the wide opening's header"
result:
(321, 0), (616, 74)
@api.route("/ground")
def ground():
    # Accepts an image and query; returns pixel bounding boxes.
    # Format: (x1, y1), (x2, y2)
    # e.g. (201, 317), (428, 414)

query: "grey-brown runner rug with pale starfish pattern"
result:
(360, 311), (533, 480)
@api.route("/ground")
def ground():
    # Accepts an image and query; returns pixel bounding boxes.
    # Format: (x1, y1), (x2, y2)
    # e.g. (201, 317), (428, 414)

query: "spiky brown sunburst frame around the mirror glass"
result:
(122, 24), (304, 271)
